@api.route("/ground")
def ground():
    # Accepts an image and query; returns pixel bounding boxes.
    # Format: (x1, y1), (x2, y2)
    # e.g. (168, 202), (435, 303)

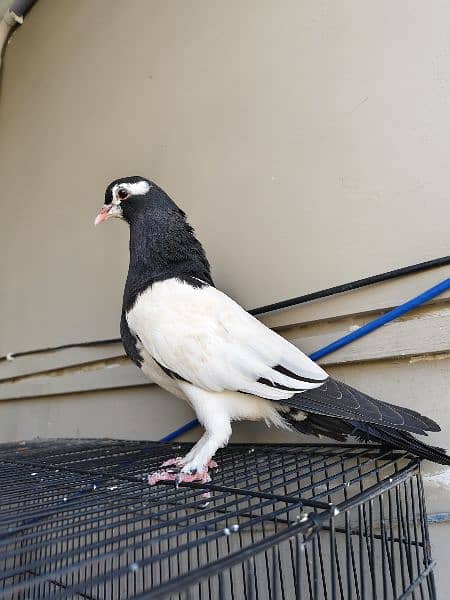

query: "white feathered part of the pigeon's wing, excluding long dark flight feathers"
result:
(127, 279), (328, 400)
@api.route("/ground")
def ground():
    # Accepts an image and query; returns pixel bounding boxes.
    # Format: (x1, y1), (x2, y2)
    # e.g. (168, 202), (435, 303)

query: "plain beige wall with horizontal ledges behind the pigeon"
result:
(0, 0), (450, 592)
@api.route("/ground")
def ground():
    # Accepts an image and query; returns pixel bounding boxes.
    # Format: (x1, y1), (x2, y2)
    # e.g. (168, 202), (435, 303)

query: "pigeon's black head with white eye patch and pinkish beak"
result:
(94, 176), (174, 225)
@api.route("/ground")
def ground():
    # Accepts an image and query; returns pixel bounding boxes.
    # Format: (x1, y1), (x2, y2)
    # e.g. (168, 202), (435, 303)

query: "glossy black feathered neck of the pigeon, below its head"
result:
(123, 209), (214, 310)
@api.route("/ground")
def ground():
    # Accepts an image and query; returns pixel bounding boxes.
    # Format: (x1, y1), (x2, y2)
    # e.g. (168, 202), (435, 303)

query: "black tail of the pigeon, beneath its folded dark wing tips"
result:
(283, 409), (450, 465)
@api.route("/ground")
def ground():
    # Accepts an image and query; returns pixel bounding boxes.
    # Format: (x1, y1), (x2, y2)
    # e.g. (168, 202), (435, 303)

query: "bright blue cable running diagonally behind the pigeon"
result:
(159, 277), (450, 442)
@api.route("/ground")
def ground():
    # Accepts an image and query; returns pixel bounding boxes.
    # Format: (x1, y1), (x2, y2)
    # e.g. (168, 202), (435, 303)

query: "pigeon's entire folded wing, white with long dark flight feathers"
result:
(128, 280), (439, 433)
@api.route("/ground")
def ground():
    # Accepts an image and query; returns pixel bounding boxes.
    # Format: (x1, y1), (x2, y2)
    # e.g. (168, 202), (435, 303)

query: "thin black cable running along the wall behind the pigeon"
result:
(0, 256), (450, 362)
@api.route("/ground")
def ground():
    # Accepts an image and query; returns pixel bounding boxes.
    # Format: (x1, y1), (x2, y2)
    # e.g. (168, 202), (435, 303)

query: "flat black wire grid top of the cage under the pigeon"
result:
(0, 440), (419, 600)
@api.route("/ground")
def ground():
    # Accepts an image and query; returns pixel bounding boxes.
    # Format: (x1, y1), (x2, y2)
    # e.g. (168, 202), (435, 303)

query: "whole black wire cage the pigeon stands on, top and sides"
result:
(0, 440), (436, 600)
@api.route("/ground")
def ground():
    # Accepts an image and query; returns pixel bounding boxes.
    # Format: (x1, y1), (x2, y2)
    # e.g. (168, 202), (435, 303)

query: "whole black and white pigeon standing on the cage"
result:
(95, 177), (450, 484)
